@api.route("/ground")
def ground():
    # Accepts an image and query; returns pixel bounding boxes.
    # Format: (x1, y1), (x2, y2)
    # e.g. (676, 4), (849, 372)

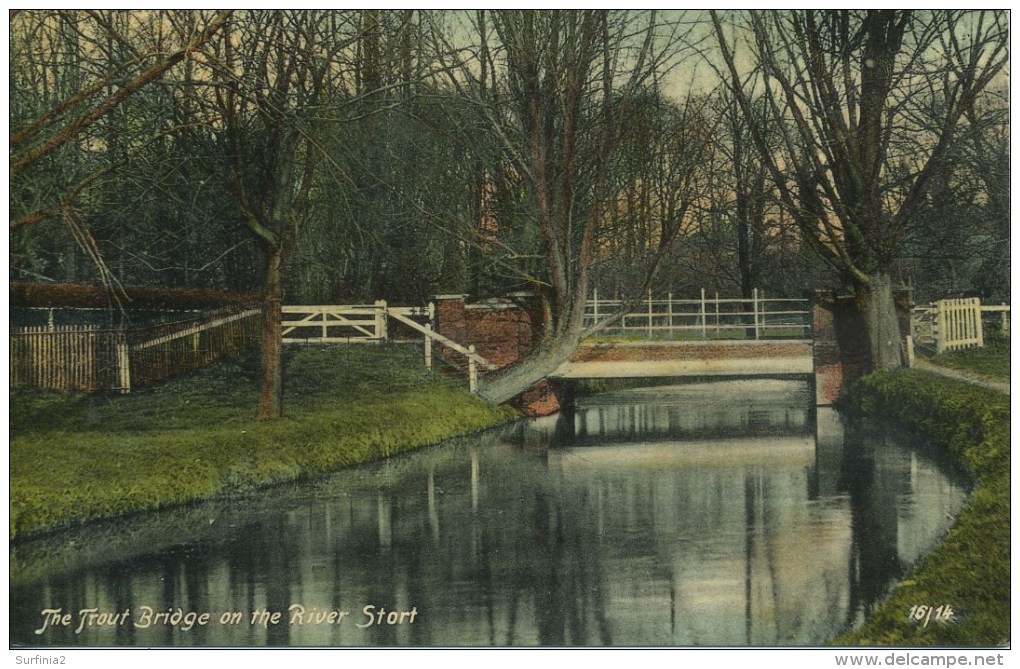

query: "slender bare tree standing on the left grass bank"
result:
(200, 10), (361, 419)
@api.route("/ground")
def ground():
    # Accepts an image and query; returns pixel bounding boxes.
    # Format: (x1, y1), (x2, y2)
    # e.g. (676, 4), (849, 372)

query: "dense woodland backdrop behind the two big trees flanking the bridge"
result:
(9, 10), (1009, 303)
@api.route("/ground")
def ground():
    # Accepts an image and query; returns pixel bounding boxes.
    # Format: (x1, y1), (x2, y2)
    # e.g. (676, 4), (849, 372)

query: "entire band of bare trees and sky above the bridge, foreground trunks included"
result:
(9, 9), (1009, 405)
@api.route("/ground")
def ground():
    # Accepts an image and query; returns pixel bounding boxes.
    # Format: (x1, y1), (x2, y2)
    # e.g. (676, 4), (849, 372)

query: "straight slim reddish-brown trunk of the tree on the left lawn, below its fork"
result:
(258, 245), (284, 420)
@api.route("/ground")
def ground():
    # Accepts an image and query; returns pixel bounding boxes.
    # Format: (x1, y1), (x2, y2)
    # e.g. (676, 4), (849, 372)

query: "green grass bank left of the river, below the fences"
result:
(10, 346), (516, 538)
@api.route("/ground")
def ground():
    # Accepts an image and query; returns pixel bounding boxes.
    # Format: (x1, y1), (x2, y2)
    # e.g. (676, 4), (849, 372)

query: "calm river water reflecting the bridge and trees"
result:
(11, 380), (964, 646)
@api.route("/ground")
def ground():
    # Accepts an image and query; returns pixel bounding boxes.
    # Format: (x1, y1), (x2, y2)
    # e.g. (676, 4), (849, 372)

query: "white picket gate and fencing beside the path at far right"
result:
(911, 298), (1010, 353)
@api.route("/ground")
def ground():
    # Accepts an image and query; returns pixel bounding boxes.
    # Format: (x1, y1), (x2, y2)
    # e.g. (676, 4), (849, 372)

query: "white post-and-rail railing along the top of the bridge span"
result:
(584, 289), (812, 340)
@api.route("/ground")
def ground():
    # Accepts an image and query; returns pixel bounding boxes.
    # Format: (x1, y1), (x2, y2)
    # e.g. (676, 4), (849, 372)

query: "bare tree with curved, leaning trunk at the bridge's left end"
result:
(430, 10), (701, 402)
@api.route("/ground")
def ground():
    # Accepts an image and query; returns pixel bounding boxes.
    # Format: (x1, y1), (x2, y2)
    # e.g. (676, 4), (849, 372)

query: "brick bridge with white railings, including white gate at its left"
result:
(283, 290), (817, 409)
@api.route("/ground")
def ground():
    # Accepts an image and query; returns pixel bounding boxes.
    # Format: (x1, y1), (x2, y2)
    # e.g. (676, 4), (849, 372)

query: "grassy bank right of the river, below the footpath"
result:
(832, 369), (1010, 647)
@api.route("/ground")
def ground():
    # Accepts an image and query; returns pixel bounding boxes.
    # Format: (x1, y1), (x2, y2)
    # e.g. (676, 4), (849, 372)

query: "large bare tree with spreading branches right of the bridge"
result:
(712, 10), (1008, 368)
